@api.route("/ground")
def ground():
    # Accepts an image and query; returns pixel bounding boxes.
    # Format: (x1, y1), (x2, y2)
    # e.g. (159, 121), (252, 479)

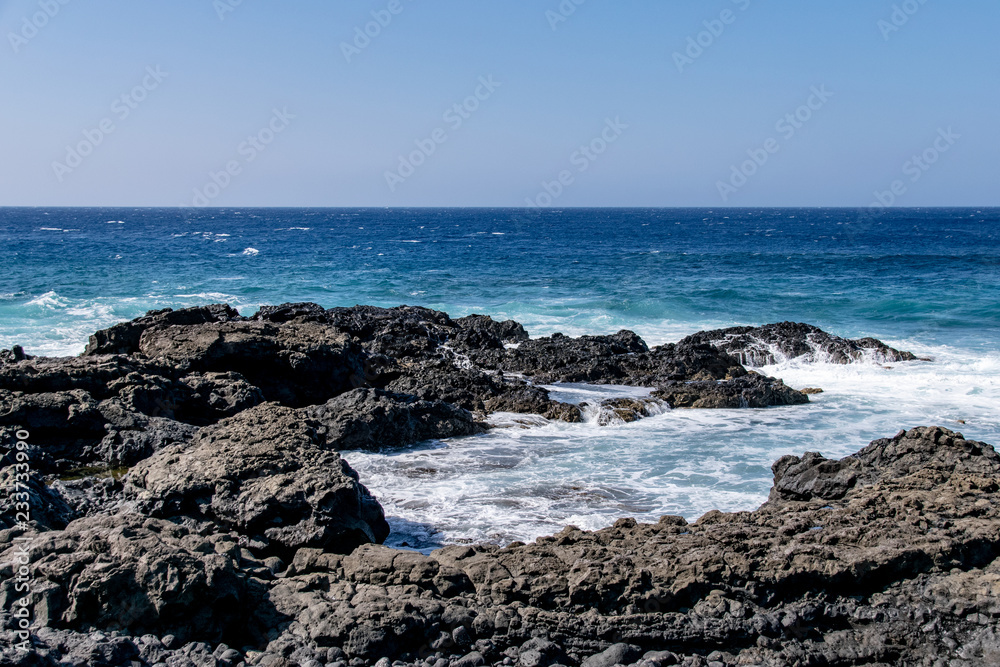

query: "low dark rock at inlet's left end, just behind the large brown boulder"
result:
(304, 389), (484, 450)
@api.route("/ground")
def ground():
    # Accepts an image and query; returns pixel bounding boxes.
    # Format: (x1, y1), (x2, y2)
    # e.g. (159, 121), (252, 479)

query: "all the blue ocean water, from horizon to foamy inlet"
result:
(0, 208), (1000, 548)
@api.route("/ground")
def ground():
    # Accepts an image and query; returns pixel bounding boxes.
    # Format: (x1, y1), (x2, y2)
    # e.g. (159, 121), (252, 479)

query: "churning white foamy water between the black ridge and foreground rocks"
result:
(345, 341), (1000, 550)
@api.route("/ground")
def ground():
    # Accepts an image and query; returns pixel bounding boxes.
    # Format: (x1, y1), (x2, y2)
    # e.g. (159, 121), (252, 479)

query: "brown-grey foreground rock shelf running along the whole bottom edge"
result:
(0, 428), (1000, 667)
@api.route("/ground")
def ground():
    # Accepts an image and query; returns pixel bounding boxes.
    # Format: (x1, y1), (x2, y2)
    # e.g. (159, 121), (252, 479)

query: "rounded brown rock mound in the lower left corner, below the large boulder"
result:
(0, 514), (262, 648)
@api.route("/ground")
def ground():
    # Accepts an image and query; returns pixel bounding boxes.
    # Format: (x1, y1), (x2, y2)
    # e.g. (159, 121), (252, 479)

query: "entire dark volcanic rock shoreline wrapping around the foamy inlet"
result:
(0, 304), (1000, 667)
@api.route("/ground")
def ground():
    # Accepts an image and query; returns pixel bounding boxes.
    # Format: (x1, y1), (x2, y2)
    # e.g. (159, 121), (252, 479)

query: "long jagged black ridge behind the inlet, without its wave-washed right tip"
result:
(0, 303), (860, 474)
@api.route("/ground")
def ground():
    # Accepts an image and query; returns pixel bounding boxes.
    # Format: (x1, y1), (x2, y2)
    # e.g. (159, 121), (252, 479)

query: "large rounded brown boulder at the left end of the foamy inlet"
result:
(125, 403), (389, 557)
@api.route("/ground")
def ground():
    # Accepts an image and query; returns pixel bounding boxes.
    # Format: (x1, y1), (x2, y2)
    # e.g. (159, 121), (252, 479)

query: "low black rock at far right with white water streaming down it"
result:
(681, 322), (917, 366)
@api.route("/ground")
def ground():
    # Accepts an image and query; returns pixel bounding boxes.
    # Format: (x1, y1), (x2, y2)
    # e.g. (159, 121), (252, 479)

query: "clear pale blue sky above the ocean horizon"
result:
(0, 0), (1000, 207)
